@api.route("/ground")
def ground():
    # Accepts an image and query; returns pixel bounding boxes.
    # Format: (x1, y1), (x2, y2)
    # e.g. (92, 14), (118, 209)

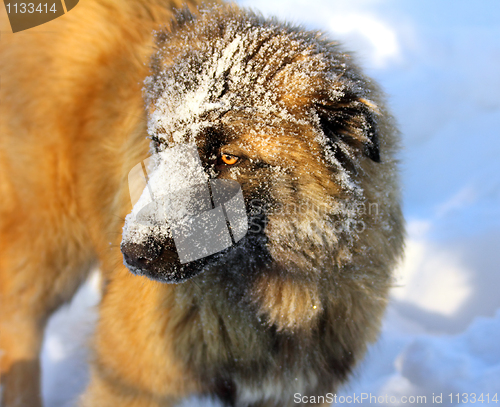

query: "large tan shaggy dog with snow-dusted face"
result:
(0, 0), (404, 407)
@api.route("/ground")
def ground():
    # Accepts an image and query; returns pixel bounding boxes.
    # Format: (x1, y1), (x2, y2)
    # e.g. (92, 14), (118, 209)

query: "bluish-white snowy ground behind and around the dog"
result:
(43, 0), (500, 407)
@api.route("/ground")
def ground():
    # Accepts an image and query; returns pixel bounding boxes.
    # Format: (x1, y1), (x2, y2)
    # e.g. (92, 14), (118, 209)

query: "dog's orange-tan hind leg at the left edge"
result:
(0, 212), (91, 407)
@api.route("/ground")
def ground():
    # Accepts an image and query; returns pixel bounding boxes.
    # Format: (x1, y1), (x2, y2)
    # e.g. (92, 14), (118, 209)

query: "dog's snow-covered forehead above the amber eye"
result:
(146, 23), (326, 144)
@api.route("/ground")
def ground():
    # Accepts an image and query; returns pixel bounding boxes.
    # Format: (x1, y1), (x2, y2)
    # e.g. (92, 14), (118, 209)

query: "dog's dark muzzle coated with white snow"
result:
(121, 144), (248, 282)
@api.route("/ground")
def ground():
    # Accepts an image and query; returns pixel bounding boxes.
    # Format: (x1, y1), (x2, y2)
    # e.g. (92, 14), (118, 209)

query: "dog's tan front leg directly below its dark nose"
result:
(80, 258), (199, 407)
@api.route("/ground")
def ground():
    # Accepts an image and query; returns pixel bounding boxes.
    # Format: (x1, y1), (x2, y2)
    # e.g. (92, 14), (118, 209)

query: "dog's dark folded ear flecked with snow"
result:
(316, 88), (380, 164)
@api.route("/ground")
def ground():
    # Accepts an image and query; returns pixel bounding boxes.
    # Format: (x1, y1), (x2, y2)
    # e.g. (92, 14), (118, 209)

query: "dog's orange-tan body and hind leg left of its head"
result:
(0, 0), (203, 407)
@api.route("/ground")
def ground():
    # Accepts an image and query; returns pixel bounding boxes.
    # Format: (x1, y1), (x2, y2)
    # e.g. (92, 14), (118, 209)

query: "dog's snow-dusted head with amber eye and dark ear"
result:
(122, 7), (379, 282)
